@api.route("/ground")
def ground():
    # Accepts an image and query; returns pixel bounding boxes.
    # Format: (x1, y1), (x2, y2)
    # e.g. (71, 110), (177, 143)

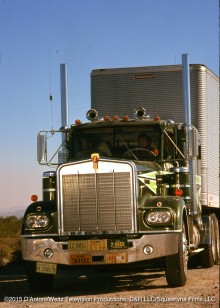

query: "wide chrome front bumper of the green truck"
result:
(21, 233), (178, 266)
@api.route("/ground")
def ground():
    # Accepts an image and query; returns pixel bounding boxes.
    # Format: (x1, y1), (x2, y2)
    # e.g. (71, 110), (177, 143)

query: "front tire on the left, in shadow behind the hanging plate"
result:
(26, 261), (54, 293)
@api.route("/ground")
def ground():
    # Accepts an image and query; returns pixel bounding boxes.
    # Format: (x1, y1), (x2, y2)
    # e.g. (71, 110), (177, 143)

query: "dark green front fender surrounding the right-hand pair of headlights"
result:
(138, 196), (187, 232)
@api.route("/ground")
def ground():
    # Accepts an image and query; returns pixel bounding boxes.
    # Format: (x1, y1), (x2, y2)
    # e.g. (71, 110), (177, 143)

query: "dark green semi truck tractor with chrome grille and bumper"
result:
(21, 55), (219, 292)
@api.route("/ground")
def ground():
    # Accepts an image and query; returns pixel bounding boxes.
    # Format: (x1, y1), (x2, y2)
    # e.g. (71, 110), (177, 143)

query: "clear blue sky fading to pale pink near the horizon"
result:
(0, 0), (219, 213)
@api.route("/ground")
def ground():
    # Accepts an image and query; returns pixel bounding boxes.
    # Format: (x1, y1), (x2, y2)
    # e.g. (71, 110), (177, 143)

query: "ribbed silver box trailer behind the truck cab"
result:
(91, 64), (220, 206)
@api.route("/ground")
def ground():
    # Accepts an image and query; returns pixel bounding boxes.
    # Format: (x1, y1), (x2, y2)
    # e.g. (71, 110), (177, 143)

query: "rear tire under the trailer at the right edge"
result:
(200, 214), (219, 268)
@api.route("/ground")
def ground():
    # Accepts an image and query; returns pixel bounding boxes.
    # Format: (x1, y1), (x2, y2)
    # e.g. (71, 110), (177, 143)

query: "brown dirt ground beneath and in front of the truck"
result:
(0, 265), (219, 308)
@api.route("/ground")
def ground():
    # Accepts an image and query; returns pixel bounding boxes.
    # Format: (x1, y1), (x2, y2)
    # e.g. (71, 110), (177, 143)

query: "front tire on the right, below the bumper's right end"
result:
(165, 225), (188, 287)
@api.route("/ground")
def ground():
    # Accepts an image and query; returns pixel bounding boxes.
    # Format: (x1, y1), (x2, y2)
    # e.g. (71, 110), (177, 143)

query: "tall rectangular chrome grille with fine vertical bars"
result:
(61, 172), (133, 233)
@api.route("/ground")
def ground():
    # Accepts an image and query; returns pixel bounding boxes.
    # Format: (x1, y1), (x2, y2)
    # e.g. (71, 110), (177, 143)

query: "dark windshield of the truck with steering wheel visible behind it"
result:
(70, 126), (161, 161)
